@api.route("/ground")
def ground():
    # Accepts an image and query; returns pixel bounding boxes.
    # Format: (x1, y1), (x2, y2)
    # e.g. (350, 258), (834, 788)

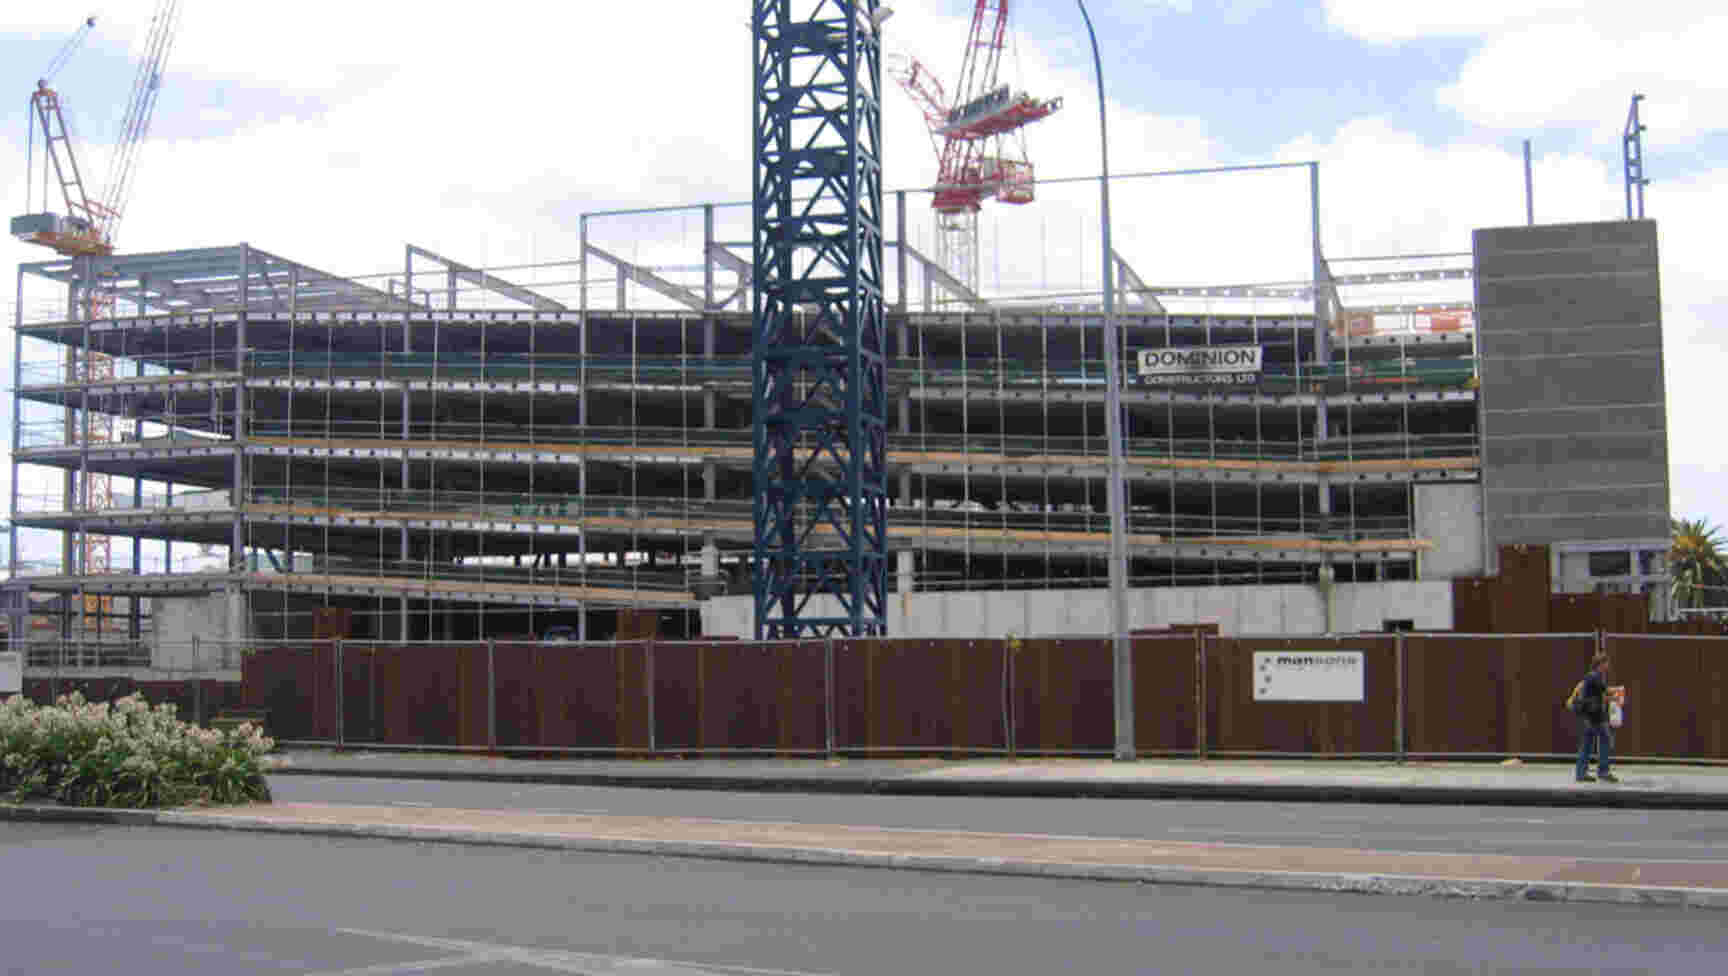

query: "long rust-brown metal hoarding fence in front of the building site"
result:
(233, 632), (1728, 760)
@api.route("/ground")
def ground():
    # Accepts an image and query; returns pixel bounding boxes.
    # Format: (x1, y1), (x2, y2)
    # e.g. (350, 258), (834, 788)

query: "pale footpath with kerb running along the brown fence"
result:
(271, 751), (1728, 810)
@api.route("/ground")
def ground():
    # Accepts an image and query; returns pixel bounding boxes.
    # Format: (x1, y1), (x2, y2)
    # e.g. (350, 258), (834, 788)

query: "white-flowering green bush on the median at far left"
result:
(0, 693), (275, 808)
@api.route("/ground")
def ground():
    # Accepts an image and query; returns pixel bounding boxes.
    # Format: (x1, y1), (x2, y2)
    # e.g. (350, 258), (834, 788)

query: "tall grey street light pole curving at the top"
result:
(1075, 0), (1134, 762)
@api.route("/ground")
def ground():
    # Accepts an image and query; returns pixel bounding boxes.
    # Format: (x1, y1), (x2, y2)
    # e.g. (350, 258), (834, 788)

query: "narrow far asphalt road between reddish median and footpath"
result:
(270, 776), (1728, 860)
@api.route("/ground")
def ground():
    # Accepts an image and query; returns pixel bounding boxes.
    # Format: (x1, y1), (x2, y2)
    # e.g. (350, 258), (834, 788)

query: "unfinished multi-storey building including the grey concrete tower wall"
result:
(7, 177), (1668, 667)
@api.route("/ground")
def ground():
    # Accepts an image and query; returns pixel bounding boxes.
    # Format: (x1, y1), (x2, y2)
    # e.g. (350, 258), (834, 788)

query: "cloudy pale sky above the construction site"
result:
(0, 0), (1728, 523)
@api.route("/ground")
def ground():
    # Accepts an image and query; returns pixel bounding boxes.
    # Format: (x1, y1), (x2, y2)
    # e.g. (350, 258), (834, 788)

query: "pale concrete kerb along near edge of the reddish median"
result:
(156, 810), (1728, 909)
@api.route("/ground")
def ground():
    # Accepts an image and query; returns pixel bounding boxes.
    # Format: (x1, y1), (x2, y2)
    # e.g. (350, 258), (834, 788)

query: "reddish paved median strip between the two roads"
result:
(108, 803), (1728, 909)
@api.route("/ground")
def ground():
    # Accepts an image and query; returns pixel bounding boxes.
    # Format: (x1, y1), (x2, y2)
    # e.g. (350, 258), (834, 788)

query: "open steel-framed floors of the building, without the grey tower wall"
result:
(12, 168), (1479, 652)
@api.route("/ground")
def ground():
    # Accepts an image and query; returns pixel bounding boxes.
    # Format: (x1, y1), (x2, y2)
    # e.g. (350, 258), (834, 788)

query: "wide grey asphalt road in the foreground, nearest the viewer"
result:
(0, 822), (1728, 976)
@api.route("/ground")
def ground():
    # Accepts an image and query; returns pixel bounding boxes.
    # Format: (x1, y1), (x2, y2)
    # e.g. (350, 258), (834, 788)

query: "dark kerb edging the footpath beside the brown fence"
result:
(266, 765), (1728, 810)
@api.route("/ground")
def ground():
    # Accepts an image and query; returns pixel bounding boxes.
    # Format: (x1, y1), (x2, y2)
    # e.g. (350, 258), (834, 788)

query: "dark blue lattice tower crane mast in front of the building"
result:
(752, 0), (888, 639)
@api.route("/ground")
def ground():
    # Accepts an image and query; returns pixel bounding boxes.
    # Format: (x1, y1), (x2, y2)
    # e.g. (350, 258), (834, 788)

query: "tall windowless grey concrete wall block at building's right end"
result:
(1474, 221), (1669, 551)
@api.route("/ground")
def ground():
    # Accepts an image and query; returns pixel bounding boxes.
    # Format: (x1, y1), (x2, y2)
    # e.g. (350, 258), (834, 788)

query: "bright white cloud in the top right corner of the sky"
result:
(1327, 0), (1728, 145)
